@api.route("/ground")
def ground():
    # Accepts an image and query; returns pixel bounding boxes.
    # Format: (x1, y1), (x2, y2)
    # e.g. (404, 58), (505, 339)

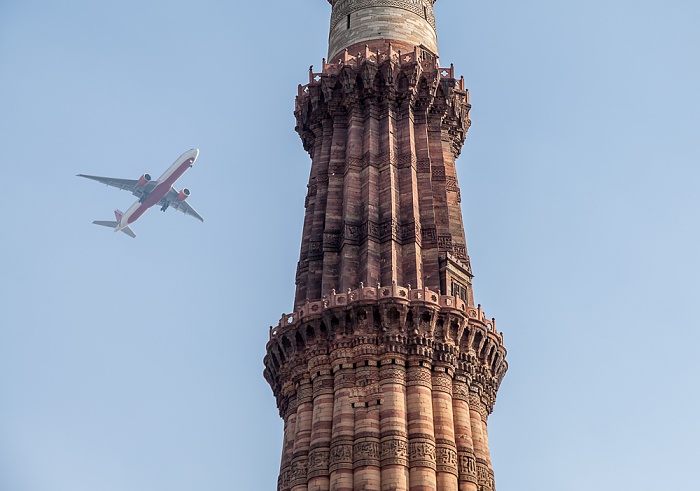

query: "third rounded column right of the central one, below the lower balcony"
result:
(452, 375), (477, 491)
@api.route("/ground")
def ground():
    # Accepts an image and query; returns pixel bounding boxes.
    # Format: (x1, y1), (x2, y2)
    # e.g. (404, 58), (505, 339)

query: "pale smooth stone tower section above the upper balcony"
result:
(328, 0), (438, 63)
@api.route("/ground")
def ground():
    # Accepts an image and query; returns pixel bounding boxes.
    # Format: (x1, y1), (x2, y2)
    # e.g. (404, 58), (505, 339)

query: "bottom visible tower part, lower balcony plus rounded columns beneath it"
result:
(264, 285), (507, 491)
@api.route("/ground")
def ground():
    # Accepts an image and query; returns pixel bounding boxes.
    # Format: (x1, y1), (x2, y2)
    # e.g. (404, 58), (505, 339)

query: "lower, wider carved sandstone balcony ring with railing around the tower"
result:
(264, 284), (508, 413)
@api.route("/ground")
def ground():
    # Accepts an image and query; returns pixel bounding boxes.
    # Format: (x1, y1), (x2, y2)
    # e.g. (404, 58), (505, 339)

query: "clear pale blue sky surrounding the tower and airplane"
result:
(0, 0), (700, 491)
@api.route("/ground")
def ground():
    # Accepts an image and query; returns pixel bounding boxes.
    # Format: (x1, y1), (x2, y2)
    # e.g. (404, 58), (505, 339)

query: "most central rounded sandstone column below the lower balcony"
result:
(379, 353), (408, 491)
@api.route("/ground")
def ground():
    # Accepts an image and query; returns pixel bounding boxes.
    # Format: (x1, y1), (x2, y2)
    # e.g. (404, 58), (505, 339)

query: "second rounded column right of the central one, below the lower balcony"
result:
(433, 366), (459, 491)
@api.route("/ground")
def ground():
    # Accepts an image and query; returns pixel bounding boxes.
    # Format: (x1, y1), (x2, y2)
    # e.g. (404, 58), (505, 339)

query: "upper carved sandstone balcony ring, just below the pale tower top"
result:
(294, 44), (471, 156)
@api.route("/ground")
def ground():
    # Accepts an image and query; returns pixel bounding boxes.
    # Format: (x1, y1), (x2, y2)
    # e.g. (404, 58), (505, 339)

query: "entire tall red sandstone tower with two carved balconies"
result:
(264, 0), (508, 491)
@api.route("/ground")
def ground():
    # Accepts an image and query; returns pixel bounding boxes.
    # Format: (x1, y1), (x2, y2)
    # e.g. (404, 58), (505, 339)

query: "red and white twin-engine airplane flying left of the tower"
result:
(77, 148), (204, 238)
